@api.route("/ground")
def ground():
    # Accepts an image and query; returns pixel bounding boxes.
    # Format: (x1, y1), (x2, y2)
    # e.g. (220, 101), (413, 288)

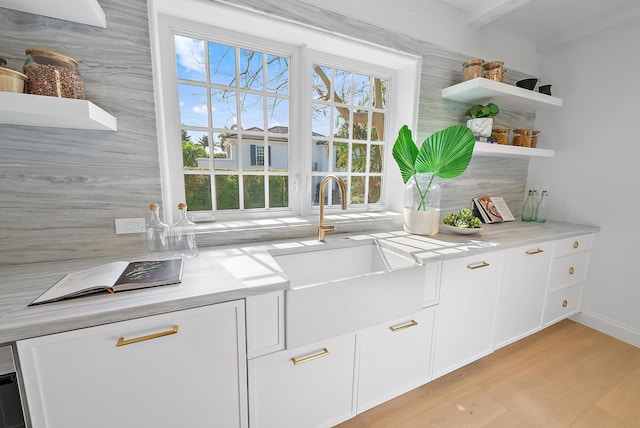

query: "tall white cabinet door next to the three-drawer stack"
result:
(494, 242), (553, 348)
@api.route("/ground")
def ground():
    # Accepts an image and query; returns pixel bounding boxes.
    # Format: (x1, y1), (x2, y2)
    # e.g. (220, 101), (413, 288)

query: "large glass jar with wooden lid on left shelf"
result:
(23, 48), (84, 100)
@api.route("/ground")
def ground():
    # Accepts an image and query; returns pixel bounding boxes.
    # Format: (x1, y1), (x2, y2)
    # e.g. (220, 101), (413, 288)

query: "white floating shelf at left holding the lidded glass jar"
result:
(0, 92), (118, 131)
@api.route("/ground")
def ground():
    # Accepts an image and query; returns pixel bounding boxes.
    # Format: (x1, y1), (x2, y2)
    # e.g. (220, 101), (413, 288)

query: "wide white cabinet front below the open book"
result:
(17, 301), (247, 428)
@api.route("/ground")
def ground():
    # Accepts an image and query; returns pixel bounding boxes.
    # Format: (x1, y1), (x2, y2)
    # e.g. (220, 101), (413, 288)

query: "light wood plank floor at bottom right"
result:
(338, 320), (640, 428)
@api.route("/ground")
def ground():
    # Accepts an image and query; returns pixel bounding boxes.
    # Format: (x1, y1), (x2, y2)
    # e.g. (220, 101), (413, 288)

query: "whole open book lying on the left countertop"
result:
(29, 259), (183, 306)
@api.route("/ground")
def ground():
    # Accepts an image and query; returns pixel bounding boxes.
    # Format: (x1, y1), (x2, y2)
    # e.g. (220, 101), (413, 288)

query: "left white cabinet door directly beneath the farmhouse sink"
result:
(246, 334), (356, 428)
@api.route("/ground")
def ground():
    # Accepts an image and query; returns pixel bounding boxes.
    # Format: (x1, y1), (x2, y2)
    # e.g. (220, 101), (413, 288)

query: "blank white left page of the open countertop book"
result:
(32, 262), (129, 304)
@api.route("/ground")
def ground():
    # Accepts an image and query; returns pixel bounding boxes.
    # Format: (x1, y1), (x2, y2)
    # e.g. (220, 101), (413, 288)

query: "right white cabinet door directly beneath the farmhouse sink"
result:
(357, 308), (435, 413)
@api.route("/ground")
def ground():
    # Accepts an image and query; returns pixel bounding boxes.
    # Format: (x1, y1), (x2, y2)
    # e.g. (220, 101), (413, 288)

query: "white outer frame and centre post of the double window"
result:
(148, 0), (421, 222)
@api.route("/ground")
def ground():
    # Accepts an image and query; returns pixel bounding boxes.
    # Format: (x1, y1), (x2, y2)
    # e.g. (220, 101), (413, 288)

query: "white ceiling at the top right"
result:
(441, 0), (640, 51)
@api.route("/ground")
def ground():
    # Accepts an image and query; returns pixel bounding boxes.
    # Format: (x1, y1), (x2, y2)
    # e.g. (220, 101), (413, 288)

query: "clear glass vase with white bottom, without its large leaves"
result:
(404, 173), (440, 235)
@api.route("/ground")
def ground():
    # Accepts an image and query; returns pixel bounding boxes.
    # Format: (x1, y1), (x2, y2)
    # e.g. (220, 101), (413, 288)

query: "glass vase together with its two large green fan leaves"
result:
(392, 125), (475, 235)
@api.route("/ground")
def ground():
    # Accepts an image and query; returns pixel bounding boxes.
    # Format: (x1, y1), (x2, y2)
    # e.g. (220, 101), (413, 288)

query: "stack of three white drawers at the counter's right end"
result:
(543, 234), (595, 327)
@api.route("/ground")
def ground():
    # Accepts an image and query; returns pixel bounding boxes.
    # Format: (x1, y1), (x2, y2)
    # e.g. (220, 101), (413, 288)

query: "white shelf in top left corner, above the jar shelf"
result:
(0, 0), (107, 28)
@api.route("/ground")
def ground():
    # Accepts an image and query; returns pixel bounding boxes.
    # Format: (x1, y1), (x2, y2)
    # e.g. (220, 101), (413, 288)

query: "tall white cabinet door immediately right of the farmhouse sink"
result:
(433, 251), (504, 378)
